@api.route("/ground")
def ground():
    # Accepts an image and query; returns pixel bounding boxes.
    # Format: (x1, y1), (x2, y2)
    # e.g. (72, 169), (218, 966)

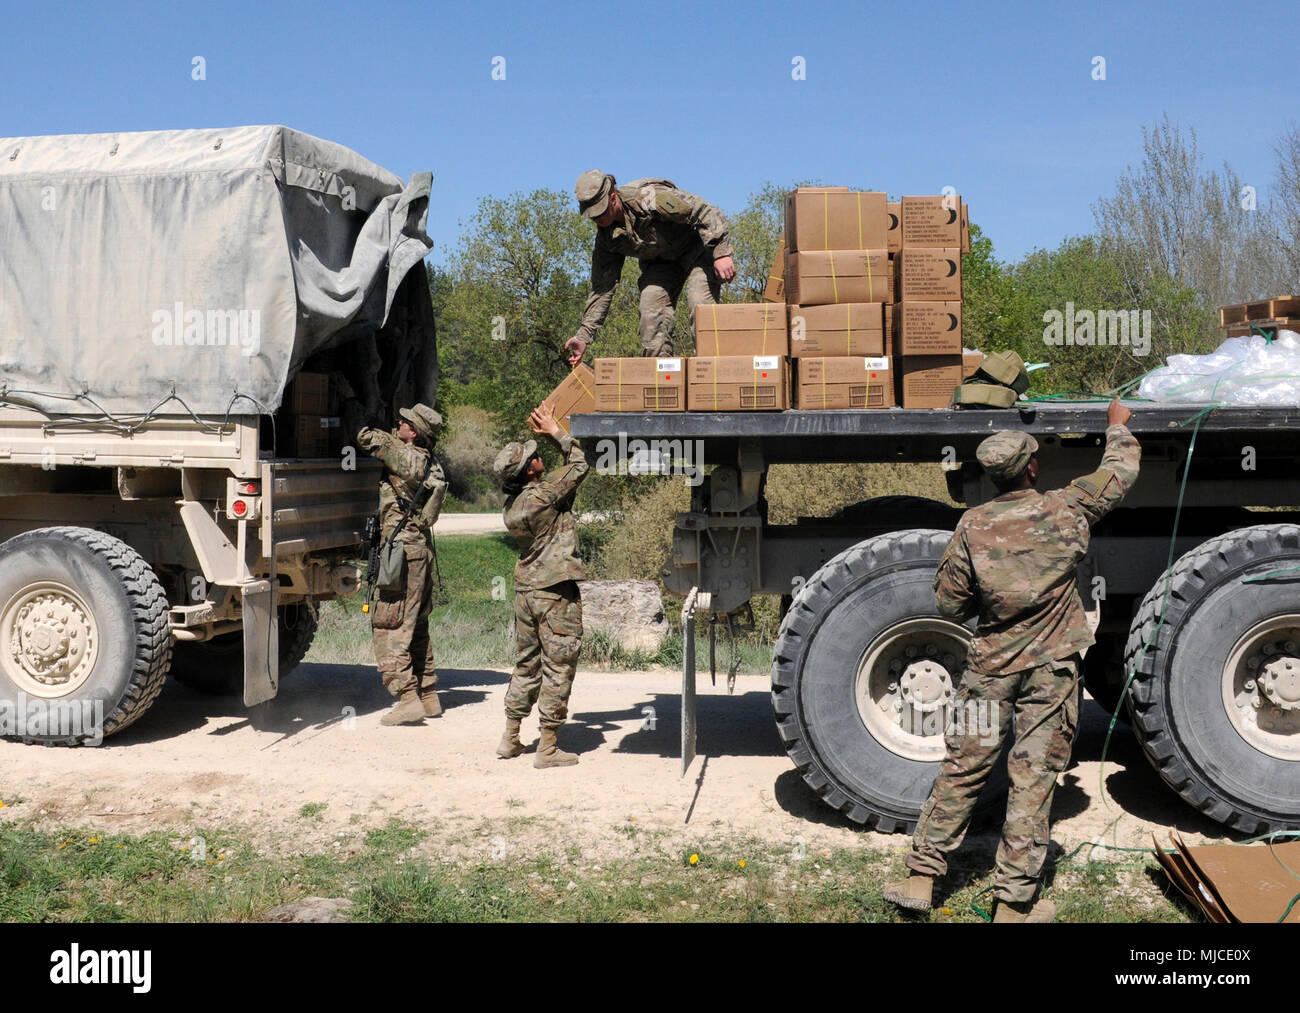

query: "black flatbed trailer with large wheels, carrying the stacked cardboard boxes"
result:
(572, 401), (1300, 834)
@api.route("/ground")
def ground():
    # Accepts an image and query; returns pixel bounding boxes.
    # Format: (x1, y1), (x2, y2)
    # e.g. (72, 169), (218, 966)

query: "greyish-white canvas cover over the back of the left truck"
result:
(0, 126), (433, 415)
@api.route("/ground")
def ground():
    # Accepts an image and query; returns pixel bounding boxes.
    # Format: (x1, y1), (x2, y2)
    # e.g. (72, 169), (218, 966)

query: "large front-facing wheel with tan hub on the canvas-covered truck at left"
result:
(0, 527), (172, 745)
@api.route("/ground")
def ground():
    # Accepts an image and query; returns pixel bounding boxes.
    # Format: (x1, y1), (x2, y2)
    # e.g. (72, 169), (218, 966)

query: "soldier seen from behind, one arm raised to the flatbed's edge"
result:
(884, 399), (1141, 922)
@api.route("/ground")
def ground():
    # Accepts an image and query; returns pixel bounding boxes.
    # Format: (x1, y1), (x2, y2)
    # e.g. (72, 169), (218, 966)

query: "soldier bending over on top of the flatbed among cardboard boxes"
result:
(564, 169), (736, 365)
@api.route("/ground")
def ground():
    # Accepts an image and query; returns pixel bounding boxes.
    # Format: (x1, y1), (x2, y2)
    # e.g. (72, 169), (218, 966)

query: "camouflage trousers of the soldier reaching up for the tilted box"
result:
(506, 580), (582, 728)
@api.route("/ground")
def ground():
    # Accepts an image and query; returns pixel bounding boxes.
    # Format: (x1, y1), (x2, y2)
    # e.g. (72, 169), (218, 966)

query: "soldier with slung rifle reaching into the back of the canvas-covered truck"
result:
(356, 404), (446, 726)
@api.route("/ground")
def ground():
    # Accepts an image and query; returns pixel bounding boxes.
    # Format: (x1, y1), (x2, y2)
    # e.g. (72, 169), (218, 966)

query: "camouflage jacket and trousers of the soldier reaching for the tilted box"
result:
(506, 436), (589, 728)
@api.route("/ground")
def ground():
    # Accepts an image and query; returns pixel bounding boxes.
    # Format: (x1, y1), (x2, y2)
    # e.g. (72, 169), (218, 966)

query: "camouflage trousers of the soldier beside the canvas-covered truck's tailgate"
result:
(371, 537), (438, 697)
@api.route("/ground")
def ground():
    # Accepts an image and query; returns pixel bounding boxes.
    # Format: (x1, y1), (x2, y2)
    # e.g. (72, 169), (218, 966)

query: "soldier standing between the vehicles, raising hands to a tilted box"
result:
(493, 404), (589, 767)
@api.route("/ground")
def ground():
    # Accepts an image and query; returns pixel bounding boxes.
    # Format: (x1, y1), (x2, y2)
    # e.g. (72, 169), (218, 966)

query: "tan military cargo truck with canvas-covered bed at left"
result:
(0, 126), (437, 744)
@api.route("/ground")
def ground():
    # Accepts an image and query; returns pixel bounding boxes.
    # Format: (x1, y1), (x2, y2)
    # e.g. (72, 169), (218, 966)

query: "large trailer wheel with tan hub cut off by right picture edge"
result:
(1125, 524), (1300, 834)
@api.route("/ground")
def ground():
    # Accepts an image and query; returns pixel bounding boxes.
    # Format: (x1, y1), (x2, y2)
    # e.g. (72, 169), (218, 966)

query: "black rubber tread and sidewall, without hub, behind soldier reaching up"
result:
(772, 529), (998, 832)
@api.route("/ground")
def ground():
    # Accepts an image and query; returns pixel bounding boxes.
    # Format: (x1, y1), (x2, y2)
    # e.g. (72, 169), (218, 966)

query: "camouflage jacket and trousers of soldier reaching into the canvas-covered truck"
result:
(356, 427), (446, 697)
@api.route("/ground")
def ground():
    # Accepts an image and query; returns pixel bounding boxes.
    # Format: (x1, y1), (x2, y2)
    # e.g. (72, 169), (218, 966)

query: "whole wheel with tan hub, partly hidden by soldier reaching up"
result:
(772, 529), (1005, 832)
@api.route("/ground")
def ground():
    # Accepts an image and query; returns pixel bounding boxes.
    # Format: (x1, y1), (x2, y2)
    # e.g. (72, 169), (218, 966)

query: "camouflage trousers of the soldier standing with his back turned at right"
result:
(907, 654), (1082, 904)
